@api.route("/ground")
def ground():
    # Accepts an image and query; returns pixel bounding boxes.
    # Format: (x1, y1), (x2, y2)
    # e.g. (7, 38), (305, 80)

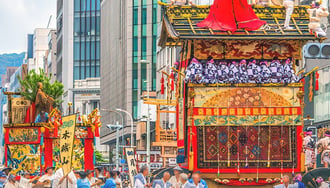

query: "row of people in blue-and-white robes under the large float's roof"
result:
(185, 57), (300, 84)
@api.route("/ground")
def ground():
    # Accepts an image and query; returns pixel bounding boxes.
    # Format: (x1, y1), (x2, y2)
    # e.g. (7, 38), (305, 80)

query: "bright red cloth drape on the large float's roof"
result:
(197, 0), (266, 32)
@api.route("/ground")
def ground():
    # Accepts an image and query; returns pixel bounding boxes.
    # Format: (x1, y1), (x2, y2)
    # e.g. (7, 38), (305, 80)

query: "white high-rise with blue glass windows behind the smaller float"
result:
(56, 0), (100, 114)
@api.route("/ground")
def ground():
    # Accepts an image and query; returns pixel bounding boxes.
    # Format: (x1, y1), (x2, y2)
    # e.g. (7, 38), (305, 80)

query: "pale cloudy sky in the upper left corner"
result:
(0, 0), (56, 54)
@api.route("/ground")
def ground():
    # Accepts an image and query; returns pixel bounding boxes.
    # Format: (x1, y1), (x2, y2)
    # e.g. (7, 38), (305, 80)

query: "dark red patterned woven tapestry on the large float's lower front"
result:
(197, 126), (297, 168)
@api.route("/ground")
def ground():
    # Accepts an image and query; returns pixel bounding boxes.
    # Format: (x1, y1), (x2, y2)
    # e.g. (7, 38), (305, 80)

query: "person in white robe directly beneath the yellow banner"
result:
(53, 168), (77, 188)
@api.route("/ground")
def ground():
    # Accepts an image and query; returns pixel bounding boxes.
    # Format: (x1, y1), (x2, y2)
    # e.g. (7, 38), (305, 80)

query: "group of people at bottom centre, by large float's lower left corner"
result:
(134, 166), (208, 188)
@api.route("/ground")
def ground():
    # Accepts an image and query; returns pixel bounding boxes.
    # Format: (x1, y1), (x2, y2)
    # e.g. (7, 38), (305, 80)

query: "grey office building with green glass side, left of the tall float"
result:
(101, 0), (160, 144)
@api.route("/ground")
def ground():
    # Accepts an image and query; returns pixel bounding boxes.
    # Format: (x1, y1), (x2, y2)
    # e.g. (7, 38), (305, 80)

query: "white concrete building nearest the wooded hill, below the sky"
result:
(27, 28), (51, 73)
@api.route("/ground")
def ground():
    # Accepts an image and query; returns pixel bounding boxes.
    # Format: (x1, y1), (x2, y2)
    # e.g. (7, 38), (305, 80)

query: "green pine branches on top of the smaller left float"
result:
(17, 69), (64, 107)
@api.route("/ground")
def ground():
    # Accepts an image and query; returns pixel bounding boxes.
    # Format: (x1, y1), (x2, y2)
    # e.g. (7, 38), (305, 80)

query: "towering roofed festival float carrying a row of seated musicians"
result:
(159, 0), (324, 187)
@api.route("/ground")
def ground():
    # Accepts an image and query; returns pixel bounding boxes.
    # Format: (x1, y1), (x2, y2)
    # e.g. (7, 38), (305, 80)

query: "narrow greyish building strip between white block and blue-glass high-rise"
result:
(44, 30), (57, 83)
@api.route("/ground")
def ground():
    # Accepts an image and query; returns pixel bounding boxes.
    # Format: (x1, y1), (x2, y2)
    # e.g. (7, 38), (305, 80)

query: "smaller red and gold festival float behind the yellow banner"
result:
(4, 86), (100, 176)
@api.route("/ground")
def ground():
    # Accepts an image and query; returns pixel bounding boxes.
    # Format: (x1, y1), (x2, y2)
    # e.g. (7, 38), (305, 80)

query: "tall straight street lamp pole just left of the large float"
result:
(140, 59), (151, 170)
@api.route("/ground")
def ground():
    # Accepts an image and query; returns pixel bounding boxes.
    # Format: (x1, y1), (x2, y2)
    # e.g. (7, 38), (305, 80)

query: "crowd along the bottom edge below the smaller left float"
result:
(0, 167), (123, 188)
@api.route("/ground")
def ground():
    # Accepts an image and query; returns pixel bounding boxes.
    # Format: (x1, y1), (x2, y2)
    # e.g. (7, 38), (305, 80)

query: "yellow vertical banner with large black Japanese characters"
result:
(60, 115), (76, 176)
